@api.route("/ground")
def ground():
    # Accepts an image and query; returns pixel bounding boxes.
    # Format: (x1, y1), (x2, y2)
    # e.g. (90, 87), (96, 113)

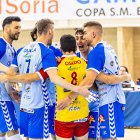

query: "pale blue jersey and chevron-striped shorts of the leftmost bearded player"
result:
(0, 38), (18, 133)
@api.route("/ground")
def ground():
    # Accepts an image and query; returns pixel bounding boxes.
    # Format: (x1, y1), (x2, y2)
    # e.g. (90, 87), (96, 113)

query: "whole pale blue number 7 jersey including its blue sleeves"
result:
(12, 42), (57, 109)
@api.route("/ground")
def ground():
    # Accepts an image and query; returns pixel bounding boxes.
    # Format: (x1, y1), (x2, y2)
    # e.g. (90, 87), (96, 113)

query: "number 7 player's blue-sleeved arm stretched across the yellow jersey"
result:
(41, 47), (89, 94)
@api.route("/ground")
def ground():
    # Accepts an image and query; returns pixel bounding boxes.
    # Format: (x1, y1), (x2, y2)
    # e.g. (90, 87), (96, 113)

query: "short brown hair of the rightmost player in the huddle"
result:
(84, 21), (103, 33)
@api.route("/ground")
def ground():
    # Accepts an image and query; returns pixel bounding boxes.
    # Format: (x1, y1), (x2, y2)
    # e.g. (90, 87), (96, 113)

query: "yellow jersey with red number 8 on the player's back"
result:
(56, 56), (89, 122)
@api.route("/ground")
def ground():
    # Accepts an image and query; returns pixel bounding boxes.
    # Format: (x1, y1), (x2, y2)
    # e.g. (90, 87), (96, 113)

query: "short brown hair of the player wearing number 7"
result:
(37, 19), (54, 35)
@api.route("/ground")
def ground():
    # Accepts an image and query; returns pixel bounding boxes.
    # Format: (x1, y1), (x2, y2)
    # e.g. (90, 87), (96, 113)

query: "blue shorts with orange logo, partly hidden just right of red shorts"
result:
(88, 112), (100, 139)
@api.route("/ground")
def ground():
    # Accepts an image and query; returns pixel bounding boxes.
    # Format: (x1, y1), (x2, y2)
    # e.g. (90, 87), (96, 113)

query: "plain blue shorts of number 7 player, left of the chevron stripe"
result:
(20, 107), (44, 139)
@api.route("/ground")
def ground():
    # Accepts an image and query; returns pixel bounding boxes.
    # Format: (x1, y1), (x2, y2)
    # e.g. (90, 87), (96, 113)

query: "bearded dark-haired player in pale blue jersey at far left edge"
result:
(0, 16), (21, 140)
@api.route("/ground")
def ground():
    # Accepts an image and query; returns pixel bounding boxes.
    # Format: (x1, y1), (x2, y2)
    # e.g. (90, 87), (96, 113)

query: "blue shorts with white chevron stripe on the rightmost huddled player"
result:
(99, 101), (125, 139)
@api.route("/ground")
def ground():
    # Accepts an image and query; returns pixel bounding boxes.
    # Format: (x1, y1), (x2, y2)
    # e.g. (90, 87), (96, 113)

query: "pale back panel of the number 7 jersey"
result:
(15, 42), (50, 109)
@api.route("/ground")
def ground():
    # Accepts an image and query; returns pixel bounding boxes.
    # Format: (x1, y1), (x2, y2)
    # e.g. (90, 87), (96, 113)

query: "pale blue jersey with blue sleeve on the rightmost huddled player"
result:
(87, 42), (125, 106)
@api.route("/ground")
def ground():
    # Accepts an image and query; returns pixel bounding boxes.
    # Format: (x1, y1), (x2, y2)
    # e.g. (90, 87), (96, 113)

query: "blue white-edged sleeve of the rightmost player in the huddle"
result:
(87, 47), (105, 73)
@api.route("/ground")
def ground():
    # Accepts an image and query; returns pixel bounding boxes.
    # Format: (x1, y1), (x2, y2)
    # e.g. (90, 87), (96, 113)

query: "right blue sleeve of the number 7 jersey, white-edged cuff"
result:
(41, 46), (57, 71)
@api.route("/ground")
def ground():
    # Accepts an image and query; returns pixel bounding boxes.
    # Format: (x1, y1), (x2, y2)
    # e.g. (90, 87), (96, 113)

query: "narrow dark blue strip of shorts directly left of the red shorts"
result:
(48, 104), (55, 135)
